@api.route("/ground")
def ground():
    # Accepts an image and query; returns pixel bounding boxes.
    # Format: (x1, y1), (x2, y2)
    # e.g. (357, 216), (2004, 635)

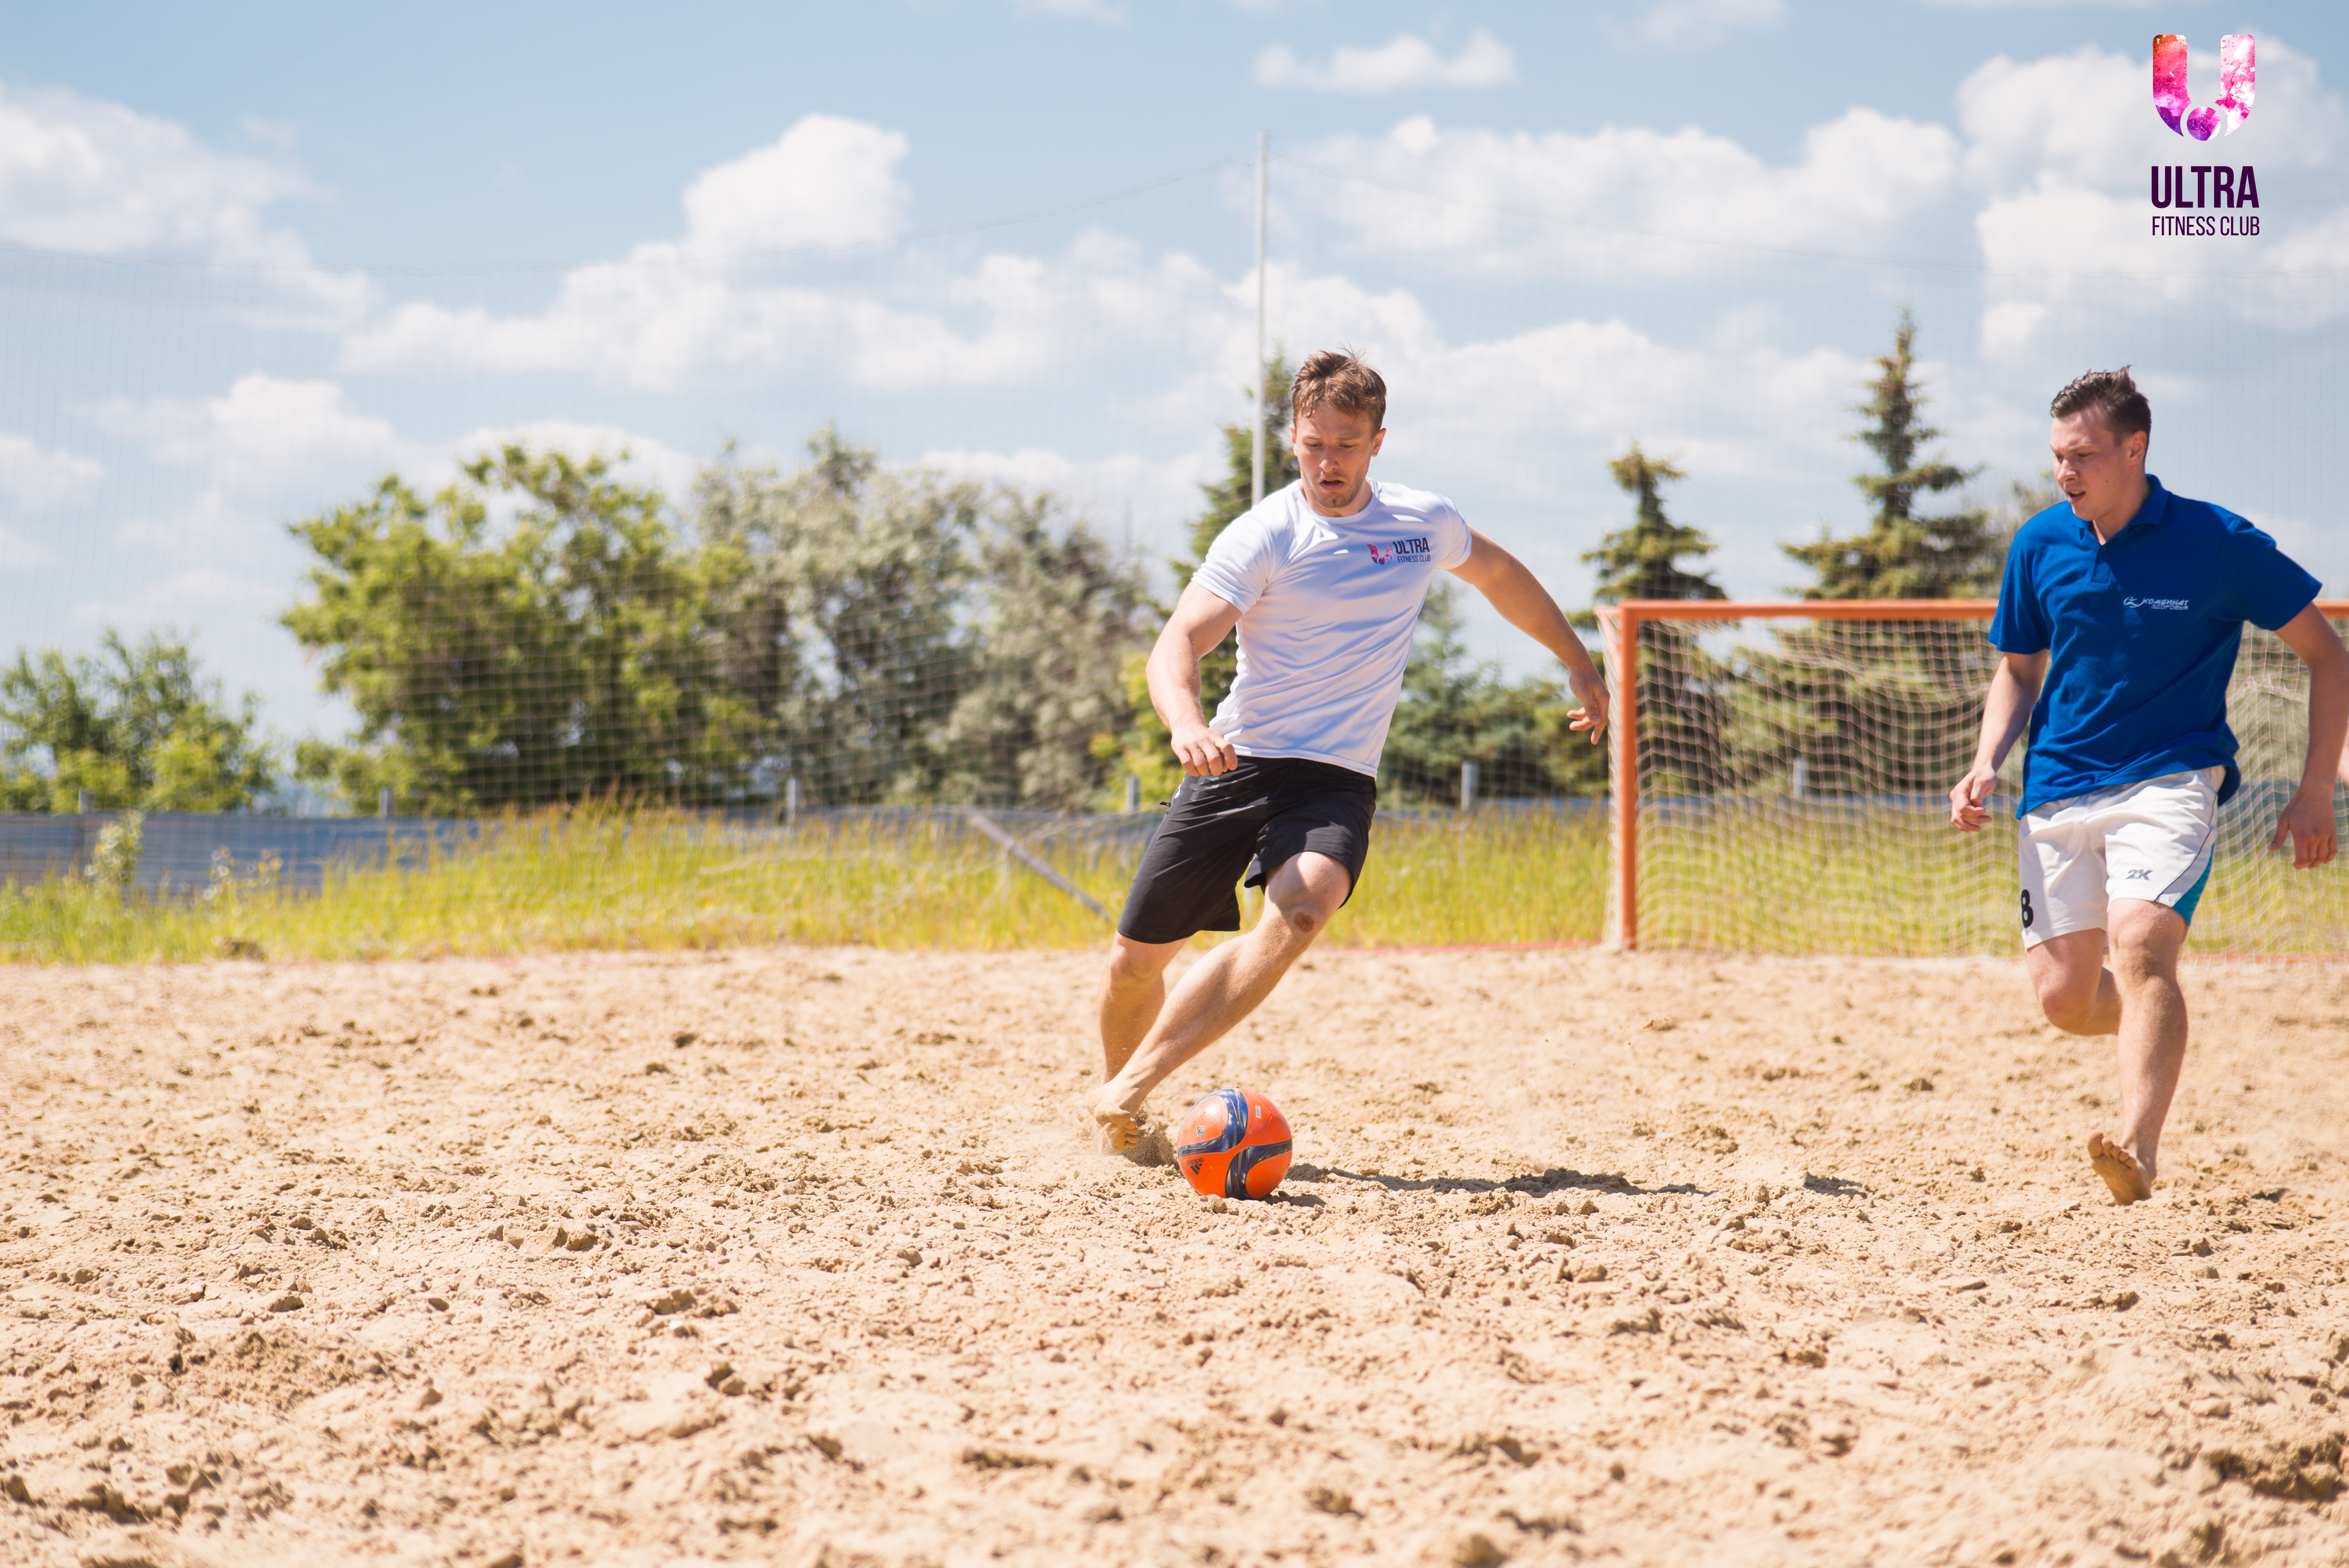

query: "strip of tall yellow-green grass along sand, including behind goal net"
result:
(0, 807), (2349, 962)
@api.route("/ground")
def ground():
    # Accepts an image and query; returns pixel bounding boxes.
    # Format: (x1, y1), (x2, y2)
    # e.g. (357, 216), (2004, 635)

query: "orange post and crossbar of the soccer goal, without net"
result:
(1593, 599), (2349, 951)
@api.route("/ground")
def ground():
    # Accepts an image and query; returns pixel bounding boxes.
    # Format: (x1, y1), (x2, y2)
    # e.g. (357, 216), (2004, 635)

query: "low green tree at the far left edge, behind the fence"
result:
(0, 629), (275, 812)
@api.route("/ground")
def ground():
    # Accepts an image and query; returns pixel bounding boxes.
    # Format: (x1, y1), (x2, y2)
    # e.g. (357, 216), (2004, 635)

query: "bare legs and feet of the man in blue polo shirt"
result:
(2027, 899), (2187, 1204)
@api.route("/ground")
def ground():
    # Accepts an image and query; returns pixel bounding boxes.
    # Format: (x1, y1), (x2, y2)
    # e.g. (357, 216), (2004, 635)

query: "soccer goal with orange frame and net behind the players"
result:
(1600, 599), (2349, 958)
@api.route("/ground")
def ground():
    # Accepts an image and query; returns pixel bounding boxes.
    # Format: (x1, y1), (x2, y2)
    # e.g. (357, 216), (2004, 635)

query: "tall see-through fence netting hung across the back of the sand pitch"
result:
(0, 138), (2349, 958)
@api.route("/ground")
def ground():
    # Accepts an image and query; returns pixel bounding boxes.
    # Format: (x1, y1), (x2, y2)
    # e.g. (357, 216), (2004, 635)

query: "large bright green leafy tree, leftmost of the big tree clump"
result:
(284, 446), (749, 812)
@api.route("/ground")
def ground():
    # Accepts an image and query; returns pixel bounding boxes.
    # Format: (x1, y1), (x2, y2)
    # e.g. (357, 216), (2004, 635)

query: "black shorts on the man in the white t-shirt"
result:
(1118, 756), (1379, 941)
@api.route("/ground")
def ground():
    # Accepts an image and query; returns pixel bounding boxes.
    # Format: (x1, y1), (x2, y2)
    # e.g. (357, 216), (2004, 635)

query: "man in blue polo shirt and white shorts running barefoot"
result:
(1950, 369), (2349, 1204)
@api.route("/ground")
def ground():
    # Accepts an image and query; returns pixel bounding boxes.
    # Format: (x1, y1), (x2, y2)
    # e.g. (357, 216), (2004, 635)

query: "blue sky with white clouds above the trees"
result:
(0, 0), (2349, 737)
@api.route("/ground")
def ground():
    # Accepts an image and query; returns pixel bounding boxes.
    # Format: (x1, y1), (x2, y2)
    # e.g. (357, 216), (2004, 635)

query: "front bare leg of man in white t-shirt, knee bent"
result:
(1092, 852), (1353, 1150)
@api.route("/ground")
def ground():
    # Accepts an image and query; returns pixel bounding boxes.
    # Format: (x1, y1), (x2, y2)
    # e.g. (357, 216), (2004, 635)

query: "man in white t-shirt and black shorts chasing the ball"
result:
(1092, 350), (1607, 1155)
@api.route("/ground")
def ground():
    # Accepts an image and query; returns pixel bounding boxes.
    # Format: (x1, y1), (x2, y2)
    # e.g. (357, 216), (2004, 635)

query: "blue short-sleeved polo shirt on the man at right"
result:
(1990, 476), (2316, 817)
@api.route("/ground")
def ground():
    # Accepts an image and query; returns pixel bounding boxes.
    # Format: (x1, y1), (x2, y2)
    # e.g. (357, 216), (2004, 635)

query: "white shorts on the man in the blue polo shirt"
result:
(2016, 768), (2227, 948)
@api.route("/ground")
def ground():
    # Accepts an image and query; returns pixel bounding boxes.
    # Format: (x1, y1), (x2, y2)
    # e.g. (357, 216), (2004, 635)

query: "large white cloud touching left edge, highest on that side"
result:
(0, 87), (366, 315)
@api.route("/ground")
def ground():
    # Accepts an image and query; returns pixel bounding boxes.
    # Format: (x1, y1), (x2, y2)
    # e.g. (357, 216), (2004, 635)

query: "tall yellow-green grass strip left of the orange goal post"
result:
(0, 812), (1604, 962)
